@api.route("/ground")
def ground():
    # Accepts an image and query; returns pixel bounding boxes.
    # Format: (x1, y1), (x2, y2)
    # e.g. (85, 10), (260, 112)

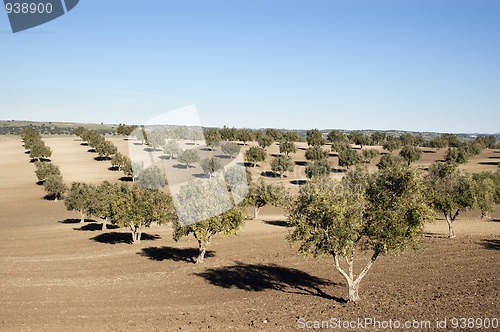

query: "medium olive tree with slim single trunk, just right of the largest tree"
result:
(426, 162), (476, 239)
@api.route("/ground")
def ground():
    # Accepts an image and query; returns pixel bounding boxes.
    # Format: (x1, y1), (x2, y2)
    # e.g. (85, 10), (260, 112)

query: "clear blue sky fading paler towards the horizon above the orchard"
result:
(0, 0), (500, 133)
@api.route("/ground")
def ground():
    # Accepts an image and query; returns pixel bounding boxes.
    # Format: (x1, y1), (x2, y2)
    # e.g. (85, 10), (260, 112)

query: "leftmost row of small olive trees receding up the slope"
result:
(20, 127), (67, 201)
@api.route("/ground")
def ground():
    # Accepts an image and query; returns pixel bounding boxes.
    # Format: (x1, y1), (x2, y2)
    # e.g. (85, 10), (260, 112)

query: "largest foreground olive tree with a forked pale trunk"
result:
(287, 167), (432, 302)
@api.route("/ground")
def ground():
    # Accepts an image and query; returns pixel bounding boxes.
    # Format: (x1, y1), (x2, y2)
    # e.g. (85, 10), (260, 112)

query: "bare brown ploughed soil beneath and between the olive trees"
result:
(0, 137), (500, 331)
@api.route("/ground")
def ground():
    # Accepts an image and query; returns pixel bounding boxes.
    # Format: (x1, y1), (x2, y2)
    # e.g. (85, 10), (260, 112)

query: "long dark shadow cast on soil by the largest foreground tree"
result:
(196, 262), (345, 303)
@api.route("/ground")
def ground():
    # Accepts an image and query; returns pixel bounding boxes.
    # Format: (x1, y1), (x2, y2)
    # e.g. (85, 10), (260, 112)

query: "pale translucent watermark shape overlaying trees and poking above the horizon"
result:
(128, 105), (248, 226)
